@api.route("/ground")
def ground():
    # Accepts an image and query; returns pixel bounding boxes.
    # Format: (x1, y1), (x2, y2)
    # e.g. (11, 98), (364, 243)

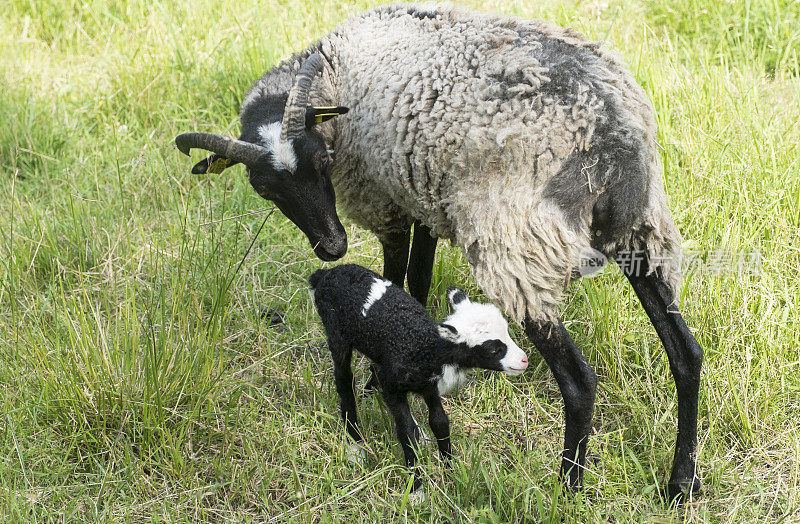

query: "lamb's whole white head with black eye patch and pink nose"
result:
(439, 287), (528, 376)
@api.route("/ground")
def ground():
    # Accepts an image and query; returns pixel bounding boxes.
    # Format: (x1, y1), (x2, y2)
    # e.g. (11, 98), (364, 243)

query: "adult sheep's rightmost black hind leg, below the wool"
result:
(621, 261), (703, 500)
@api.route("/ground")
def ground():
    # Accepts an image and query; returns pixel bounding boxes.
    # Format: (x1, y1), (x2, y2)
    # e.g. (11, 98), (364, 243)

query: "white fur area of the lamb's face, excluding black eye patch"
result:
(442, 290), (528, 376)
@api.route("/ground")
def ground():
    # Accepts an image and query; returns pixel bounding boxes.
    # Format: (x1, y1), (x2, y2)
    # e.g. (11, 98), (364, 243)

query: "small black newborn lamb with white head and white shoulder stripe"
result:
(308, 264), (528, 490)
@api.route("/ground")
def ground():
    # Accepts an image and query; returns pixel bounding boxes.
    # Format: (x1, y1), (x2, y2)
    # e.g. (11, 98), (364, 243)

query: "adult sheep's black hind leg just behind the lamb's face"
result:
(525, 317), (597, 489)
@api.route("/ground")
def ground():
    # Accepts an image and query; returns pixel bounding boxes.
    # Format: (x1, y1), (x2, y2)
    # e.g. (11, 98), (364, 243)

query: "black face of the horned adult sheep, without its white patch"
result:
(247, 129), (347, 261)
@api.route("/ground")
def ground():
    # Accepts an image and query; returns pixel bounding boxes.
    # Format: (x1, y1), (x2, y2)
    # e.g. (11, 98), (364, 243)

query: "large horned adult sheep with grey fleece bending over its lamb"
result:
(176, 6), (703, 498)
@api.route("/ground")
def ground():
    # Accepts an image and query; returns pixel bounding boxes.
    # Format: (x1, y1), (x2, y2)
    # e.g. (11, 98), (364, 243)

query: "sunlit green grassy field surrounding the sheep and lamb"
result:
(0, 0), (800, 522)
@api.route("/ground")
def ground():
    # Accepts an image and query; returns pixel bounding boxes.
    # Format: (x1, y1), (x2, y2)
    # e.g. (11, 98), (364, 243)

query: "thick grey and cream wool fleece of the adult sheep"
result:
(242, 5), (680, 321)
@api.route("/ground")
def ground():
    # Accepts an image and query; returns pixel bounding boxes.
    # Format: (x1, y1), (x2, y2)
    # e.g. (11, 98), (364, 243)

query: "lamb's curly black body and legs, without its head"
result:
(309, 265), (454, 489)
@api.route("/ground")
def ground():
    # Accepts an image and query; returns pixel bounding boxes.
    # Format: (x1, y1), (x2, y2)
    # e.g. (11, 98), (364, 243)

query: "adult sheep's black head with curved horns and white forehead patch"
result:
(175, 53), (347, 260)
